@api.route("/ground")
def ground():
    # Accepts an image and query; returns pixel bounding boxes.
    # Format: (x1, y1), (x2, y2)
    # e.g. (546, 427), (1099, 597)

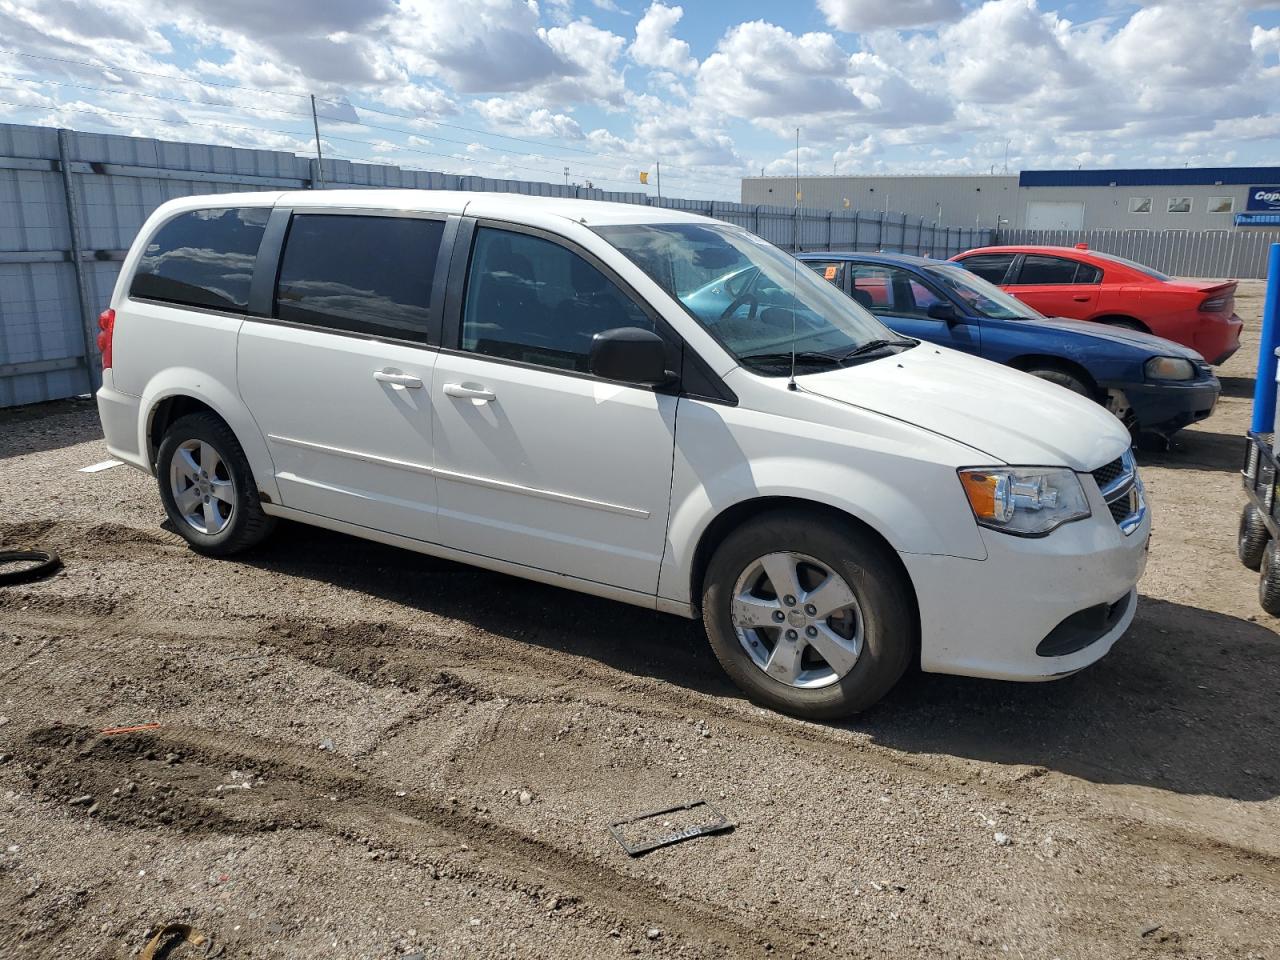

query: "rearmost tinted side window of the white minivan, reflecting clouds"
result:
(129, 207), (271, 310)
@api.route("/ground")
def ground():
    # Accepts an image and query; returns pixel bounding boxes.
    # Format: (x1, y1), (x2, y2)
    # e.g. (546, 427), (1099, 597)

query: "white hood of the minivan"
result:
(797, 343), (1130, 471)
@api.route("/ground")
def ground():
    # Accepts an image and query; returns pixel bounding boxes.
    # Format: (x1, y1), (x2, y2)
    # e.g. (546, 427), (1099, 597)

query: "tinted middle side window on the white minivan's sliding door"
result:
(275, 214), (444, 342)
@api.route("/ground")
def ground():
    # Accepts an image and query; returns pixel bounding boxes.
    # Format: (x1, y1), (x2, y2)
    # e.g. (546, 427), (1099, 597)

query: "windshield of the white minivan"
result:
(595, 223), (914, 376)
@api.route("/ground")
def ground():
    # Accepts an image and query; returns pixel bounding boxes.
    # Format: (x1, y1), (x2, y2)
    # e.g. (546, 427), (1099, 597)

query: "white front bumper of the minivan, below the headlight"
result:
(900, 477), (1151, 680)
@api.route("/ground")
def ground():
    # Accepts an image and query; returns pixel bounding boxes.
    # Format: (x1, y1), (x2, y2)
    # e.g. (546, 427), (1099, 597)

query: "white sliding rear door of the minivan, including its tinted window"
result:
(238, 214), (445, 540)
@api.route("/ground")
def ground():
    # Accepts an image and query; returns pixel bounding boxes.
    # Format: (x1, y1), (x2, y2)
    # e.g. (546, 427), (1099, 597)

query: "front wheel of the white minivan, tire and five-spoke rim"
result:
(703, 509), (918, 719)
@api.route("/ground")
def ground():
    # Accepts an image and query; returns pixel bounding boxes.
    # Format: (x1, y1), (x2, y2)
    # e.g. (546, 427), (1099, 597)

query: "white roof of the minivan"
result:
(206, 189), (719, 227)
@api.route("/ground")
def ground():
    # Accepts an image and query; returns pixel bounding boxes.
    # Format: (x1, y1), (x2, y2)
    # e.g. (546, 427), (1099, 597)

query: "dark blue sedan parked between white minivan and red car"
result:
(800, 253), (1221, 438)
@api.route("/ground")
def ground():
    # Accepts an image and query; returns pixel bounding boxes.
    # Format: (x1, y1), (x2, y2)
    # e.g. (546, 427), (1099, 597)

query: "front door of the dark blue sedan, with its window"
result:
(849, 262), (982, 355)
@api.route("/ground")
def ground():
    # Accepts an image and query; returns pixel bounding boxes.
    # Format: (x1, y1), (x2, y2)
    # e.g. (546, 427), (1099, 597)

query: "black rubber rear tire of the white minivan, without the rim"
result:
(156, 413), (275, 557)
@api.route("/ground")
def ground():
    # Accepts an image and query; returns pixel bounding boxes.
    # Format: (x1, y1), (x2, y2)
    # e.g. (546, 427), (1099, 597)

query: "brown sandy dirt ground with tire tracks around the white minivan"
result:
(0, 283), (1280, 960)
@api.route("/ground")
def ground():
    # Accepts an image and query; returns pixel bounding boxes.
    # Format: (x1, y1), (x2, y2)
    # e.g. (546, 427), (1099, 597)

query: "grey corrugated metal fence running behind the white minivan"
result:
(0, 124), (991, 407)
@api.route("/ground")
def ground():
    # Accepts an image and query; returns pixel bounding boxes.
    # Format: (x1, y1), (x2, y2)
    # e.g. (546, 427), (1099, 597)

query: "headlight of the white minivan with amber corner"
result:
(960, 467), (1091, 536)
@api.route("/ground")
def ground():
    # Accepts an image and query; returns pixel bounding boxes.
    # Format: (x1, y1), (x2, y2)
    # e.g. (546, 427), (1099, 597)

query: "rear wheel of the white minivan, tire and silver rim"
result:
(156, 413), (275, 557)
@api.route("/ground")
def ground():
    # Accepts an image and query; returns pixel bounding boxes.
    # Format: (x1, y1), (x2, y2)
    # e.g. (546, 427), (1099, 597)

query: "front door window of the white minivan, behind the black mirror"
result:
(462, 227), (653, 372)
